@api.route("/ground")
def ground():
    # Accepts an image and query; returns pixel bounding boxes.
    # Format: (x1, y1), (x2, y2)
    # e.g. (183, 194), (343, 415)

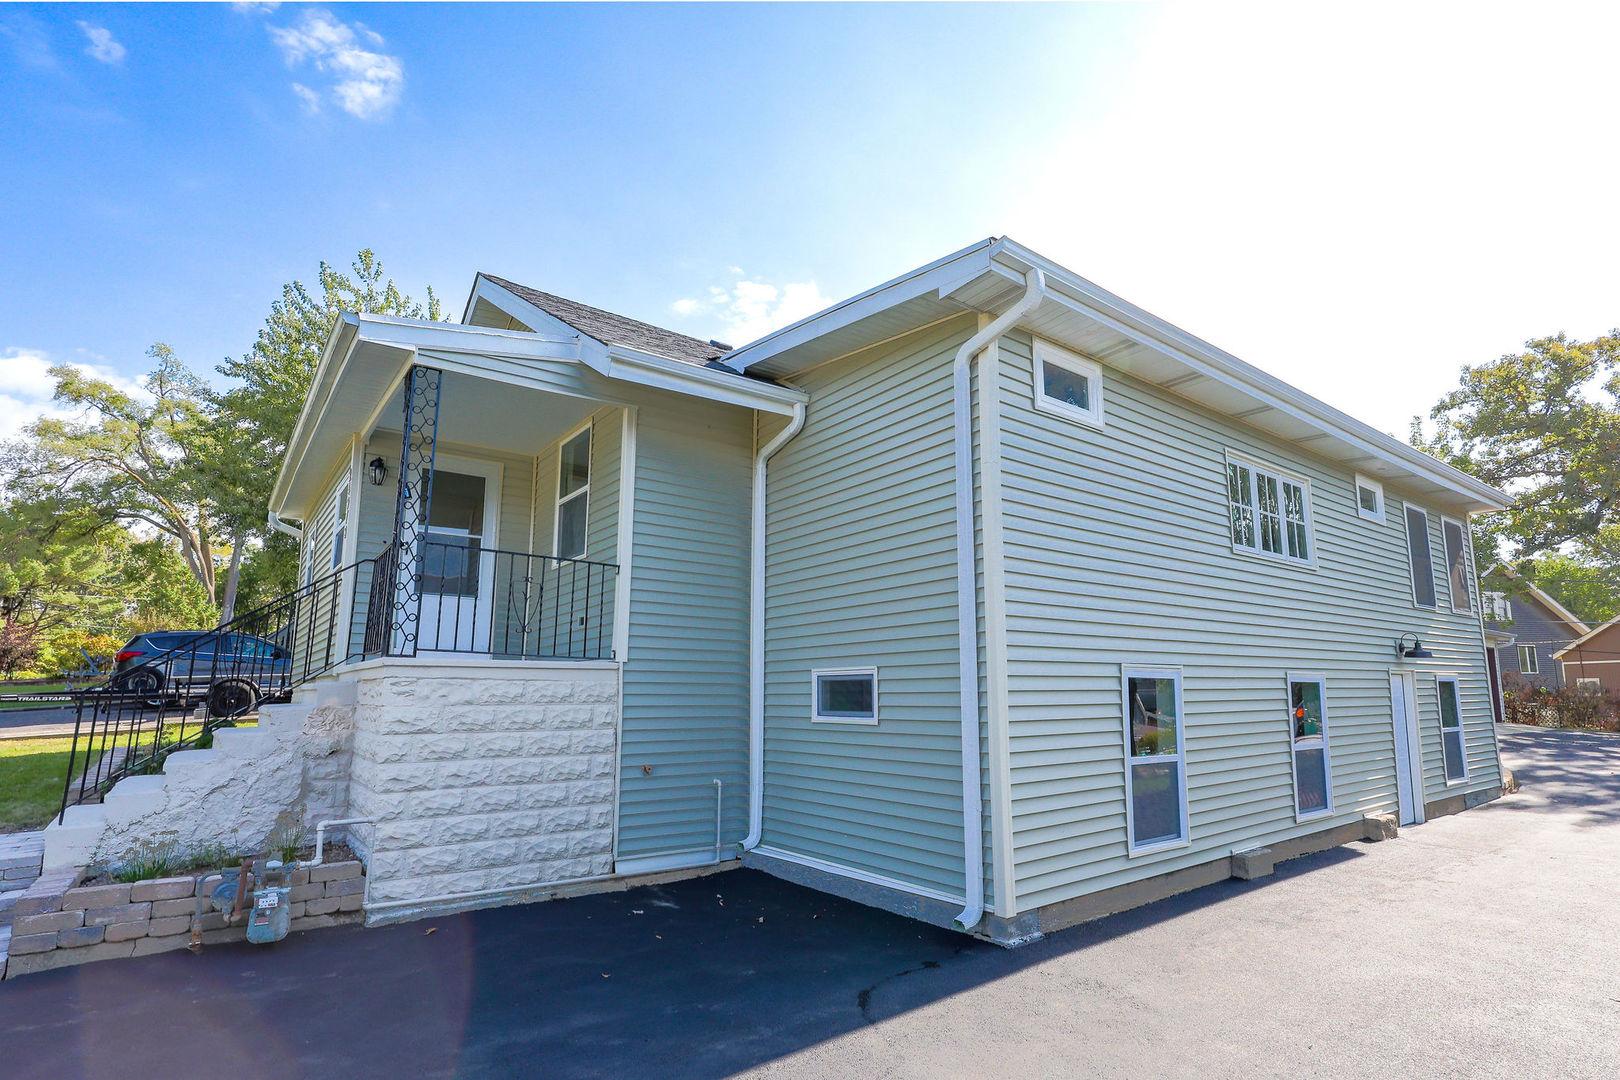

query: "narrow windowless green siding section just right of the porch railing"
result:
(615, 395), (753, 860)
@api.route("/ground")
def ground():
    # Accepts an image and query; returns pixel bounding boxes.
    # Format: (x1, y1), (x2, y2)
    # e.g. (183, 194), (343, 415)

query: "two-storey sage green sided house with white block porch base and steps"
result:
(47, 238), (1503, 942)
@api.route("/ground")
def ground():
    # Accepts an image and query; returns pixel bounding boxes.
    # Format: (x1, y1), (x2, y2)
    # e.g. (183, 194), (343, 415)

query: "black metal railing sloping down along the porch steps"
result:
(58, 559), (374, 816)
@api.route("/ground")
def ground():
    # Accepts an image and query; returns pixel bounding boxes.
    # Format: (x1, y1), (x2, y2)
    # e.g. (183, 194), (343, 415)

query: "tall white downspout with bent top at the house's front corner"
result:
(951, 269), (1047, 929)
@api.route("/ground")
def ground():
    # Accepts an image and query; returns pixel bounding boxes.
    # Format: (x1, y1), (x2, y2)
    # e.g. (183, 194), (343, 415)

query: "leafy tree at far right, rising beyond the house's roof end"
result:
(1413, 330), (1620, 566)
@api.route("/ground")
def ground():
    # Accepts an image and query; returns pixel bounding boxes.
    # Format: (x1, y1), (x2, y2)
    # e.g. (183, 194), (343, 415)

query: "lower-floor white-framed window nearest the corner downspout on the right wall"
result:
(1119, 665), (1191, 855)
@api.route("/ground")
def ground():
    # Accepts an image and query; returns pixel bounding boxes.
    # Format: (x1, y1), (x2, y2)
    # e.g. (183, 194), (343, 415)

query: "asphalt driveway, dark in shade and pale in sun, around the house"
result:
(0, 729), (1620, 1080)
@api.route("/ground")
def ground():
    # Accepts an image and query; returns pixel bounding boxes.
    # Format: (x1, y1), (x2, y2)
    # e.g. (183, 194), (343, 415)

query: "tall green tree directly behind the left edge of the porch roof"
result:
(209, 248), (444, 619)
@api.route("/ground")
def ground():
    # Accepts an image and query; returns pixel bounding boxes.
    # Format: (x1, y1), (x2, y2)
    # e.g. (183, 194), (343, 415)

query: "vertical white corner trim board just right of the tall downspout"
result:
(978, 338), (1017, 918)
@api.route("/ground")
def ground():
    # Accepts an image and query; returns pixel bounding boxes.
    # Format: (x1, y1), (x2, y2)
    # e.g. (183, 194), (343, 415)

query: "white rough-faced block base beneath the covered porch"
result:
(345, 657), (619, 921)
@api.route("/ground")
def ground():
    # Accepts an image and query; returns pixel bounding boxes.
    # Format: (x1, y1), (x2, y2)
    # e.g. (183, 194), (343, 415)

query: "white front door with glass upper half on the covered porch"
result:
(416, 470), (496, 653)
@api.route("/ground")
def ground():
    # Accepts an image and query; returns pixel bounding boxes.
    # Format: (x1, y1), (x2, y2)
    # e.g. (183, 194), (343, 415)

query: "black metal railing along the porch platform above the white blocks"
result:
(365, 538), (619, 661)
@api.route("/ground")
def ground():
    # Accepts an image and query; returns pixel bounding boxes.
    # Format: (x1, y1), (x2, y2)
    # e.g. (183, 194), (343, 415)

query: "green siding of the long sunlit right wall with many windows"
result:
(1001, 335), (1499, 910)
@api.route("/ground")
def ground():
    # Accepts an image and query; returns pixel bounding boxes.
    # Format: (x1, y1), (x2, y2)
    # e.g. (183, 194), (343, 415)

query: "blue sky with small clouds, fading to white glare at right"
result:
(0, 3), (1620, 434)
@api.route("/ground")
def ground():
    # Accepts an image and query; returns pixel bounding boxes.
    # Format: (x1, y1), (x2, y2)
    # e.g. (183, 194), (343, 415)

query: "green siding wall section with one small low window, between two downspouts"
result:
(761, 319), (974, 897)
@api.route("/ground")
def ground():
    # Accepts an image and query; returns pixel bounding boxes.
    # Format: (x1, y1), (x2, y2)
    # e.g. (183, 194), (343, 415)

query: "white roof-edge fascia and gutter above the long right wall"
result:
(995, 238), (1510, 510)
